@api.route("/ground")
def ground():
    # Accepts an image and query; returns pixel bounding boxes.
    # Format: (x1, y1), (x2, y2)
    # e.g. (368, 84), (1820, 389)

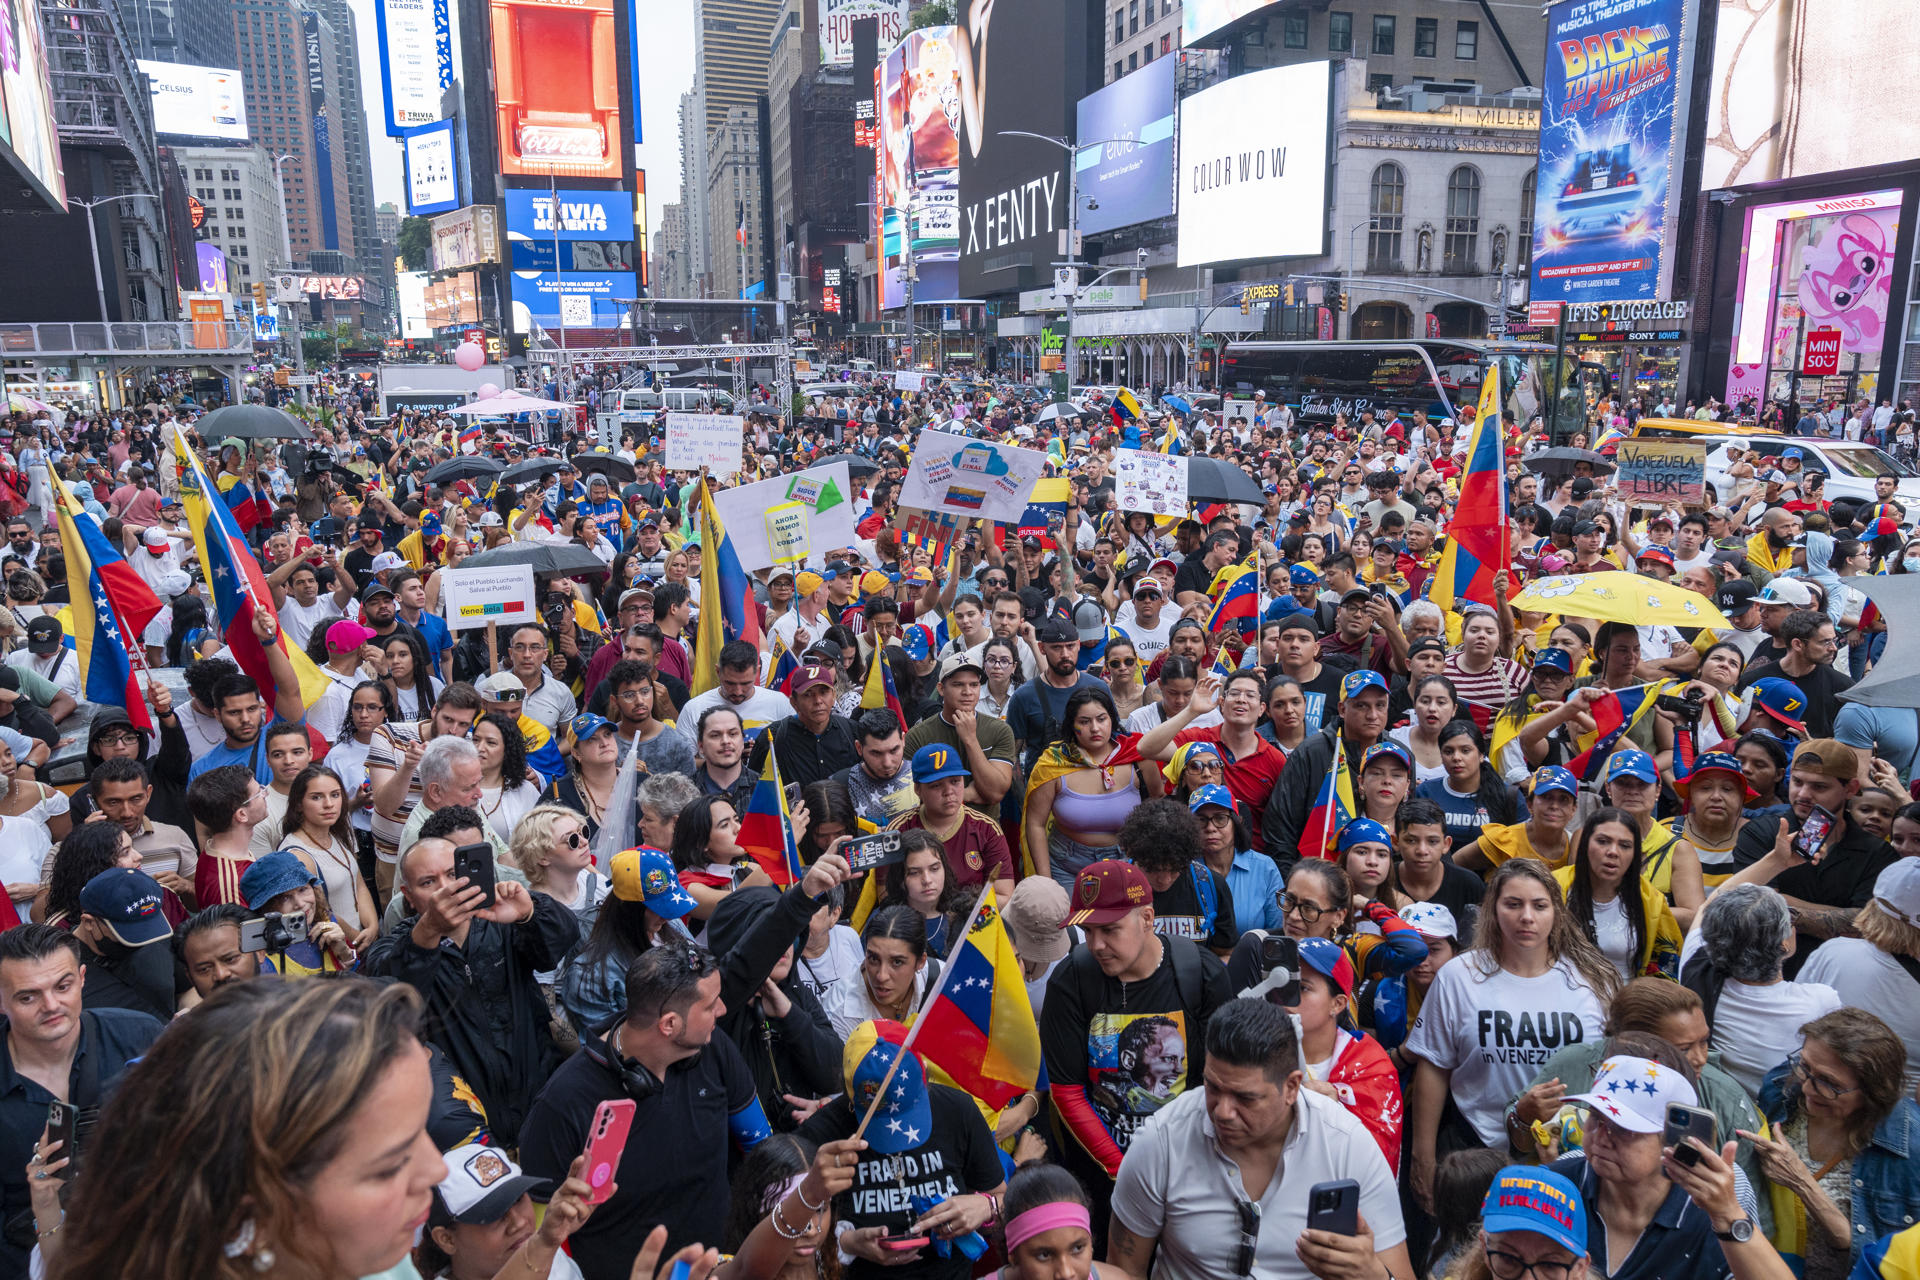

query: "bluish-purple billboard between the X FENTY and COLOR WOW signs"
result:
(1073, 58), (1175, 234)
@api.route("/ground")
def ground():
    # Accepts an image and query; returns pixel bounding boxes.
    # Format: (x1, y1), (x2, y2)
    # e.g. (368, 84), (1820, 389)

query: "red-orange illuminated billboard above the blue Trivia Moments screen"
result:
(488, 0), (622, 180)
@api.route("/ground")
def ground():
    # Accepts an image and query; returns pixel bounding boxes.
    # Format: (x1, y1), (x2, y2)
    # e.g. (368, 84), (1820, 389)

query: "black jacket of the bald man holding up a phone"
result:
(361, 892), (580, 1148)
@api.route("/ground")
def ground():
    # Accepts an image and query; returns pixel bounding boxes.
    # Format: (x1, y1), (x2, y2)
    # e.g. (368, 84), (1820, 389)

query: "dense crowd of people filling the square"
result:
(0, 364), (1920, 1280)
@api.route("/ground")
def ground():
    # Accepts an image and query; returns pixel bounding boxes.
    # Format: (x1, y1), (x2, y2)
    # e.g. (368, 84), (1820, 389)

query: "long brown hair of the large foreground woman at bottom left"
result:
(50, 977), (420, 1280)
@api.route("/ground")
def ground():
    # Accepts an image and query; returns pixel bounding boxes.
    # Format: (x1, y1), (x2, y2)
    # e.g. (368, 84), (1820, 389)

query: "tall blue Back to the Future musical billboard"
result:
(1530, 0), (1697, 301)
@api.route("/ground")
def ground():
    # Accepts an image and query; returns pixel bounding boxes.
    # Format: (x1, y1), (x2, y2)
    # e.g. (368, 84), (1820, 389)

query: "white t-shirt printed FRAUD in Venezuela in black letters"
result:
(1407, 952), (1607, 1150)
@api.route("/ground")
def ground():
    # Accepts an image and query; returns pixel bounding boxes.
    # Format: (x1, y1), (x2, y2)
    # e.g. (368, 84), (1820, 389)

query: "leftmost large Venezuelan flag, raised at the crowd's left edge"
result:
(54, 484), (159, 733)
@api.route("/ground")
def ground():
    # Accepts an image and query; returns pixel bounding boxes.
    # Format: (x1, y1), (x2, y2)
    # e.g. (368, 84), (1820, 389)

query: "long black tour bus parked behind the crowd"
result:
(1219, 338), (1611, 426)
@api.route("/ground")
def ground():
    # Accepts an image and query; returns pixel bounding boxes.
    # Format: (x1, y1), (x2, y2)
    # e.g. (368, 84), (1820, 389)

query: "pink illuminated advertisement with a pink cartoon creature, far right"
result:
(1726, 190), (1901, 405)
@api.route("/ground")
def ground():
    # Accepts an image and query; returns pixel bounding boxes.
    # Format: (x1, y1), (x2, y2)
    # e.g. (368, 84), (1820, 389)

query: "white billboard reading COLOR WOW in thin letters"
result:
(1179, 61), (1332, 267)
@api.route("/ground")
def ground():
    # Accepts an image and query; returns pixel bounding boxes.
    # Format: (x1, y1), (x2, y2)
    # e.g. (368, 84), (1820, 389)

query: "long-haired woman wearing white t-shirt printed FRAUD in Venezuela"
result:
(1405, 858), (1620, 1207)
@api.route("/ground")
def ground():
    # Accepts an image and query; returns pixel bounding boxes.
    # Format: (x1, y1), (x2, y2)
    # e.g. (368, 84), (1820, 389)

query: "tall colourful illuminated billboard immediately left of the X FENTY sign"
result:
(874, 27), (960, 309)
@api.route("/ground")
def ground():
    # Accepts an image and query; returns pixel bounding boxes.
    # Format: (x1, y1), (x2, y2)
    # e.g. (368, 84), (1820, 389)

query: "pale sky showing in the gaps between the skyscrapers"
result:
(349, 0), (695, 244)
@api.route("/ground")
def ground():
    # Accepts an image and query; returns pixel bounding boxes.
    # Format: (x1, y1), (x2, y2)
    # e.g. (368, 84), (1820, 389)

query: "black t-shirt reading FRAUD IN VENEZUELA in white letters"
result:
(799, 1082), (1006, 1280)
